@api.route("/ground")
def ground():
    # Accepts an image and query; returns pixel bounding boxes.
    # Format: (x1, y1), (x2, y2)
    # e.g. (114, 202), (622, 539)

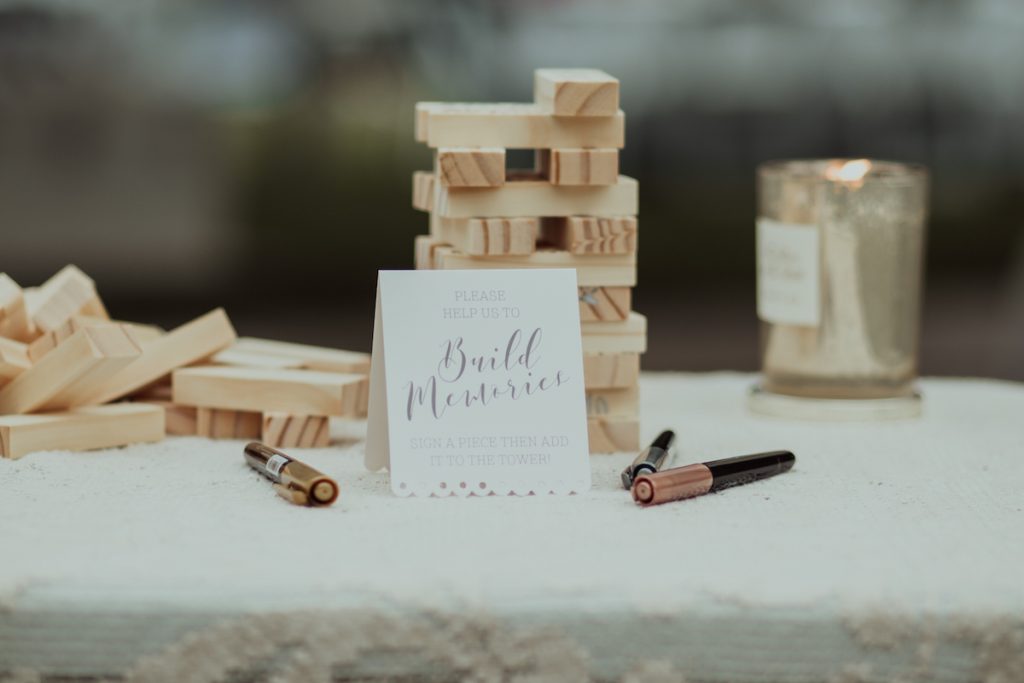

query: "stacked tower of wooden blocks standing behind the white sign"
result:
(413, 69), (647, 453)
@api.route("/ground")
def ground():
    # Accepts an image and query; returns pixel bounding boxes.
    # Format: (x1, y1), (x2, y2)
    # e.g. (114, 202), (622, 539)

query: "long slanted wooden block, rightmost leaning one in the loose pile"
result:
(82, 308), (236, 403)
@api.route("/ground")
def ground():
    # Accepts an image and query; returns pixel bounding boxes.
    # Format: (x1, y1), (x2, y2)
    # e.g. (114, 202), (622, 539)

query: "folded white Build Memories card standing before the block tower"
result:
(366, 269), (590, 496)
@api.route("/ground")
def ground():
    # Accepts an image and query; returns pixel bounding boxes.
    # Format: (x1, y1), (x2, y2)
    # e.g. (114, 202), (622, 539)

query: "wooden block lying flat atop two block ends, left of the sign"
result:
(173, 366), (368, 416)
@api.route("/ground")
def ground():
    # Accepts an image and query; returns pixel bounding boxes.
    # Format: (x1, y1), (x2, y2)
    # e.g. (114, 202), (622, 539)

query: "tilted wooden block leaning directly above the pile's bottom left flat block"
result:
(0, 325), (141, 414)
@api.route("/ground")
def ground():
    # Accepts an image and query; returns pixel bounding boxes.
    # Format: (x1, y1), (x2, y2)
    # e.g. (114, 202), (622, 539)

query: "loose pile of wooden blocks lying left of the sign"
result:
(0, 265), (370, 458)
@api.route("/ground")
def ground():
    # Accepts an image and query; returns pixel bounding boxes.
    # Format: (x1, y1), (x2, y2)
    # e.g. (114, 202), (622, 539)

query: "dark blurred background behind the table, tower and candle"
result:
(0, 0), (1024, 379)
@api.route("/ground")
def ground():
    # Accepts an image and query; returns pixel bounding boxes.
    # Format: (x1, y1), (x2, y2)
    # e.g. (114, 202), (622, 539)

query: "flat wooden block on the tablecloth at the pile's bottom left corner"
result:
(0, 403), (164, 458)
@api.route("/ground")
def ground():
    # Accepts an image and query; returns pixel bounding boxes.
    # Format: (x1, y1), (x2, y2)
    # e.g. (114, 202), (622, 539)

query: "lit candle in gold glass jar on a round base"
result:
(750, 159), (928, 419)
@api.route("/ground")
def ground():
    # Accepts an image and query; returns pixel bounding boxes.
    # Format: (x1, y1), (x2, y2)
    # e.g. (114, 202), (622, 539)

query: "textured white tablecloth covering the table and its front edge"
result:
(0, 374), (1024, 683)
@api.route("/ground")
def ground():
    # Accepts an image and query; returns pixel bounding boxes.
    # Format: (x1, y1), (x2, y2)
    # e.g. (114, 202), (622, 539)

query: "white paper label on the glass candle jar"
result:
(757, 218), (821, 327)
